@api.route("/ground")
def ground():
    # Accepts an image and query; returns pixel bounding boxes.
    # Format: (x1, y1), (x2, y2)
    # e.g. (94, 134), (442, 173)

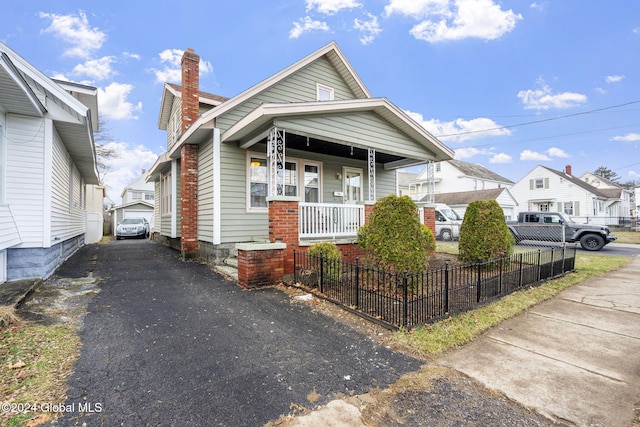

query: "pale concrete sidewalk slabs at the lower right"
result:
(438, 257), (640, 427)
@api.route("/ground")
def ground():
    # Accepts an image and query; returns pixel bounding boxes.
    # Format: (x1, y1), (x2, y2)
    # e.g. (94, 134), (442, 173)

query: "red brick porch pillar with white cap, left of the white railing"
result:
(267, 196), (300, 275)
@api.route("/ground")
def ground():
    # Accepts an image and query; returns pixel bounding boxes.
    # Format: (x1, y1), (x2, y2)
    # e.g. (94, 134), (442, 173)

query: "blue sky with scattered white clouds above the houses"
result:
(0, 0), (640, 203)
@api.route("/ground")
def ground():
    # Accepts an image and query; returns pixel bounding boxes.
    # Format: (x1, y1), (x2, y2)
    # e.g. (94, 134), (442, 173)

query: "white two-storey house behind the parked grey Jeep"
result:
(510, 165), (622, 225)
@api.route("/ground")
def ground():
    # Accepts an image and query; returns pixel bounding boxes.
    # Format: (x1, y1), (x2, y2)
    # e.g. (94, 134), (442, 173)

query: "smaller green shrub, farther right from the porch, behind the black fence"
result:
(458, 200), (515, 262)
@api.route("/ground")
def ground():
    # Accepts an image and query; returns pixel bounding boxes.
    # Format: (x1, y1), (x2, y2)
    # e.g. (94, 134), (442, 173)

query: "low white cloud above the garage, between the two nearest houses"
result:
(102, 142), (158, 205)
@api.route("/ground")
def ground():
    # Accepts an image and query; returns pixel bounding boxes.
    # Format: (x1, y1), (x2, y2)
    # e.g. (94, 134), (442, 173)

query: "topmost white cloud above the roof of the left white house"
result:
(39, 10), (107, 58)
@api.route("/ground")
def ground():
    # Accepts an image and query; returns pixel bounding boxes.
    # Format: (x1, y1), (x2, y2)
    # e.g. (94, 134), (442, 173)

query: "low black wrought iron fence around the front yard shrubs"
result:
(294, 247), (576, 328)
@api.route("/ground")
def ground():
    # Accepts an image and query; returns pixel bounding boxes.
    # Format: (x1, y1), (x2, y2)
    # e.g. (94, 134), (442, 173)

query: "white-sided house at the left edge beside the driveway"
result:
(0, 42), (99, 283)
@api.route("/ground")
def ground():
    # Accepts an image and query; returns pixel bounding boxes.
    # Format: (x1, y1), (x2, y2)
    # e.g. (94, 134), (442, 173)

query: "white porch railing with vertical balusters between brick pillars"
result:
(299, 203), (364, 239)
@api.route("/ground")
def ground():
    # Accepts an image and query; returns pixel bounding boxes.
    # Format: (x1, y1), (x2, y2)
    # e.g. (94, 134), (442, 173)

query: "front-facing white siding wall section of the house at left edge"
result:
(5, 114), (49, 248)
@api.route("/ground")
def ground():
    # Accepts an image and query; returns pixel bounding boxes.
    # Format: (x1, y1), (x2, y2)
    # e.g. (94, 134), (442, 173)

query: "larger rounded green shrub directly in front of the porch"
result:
(358, 195), (435, 273)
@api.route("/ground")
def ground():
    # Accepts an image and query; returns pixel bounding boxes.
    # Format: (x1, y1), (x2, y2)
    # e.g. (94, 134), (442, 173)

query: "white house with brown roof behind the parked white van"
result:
(411, 159), (513, 202)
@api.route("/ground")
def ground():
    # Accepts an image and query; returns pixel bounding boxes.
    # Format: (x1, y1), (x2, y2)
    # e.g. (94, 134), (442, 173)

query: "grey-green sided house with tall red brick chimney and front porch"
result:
(149, 43), (453, 262)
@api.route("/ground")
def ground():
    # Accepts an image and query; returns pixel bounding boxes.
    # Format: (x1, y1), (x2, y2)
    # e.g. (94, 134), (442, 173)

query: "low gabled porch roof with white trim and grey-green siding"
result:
(221, 98), (453, 169)
